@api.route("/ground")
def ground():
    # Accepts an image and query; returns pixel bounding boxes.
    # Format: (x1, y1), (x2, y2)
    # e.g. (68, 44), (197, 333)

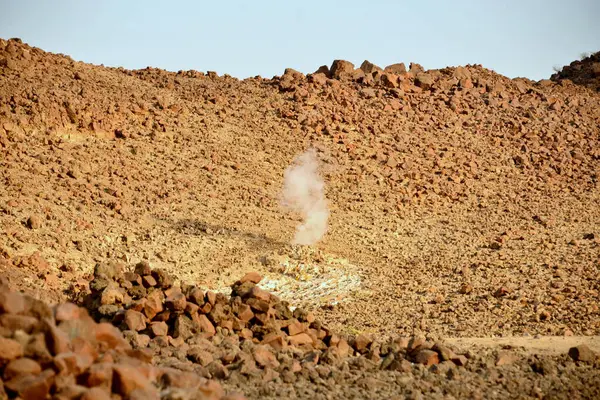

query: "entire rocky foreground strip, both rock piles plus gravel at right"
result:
(0, 262), (600, 400)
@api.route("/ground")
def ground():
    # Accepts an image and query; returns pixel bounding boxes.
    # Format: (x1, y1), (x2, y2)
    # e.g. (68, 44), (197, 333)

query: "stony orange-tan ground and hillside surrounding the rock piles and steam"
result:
(0, 36), (600, 398)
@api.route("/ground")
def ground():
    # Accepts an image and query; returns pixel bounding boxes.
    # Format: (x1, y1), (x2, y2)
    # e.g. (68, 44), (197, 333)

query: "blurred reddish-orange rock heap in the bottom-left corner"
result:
(0, 278), (241, 400)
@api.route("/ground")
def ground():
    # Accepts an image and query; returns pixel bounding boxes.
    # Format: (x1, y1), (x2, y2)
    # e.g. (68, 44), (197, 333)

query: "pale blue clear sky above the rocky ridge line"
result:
(0, 0), (600, 80)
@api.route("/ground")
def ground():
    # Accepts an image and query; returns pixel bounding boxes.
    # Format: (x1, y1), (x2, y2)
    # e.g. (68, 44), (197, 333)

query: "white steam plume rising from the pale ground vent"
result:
(282, 148), (329, 245)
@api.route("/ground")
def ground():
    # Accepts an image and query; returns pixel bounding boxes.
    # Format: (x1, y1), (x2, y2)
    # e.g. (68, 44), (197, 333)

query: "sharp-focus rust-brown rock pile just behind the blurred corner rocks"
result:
(82, 262), (467, 380)
